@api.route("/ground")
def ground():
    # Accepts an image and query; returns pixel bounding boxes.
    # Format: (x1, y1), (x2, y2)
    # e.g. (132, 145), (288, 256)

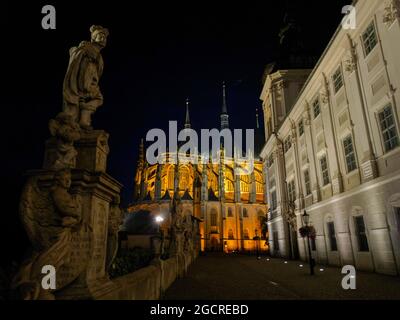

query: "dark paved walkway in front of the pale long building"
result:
(164, 253), (400, 300)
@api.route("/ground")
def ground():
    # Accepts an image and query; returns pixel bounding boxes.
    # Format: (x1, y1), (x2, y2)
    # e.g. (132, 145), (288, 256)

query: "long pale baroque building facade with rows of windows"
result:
(261, 0), (400, 275)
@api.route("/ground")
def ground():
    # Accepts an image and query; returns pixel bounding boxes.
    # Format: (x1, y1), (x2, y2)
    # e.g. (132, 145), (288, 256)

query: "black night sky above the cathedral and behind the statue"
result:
(0, 0), (351, 265)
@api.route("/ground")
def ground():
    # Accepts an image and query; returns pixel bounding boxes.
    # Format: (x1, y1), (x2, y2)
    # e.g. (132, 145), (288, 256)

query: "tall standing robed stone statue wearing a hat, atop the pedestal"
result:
(63, 26), (109, 129)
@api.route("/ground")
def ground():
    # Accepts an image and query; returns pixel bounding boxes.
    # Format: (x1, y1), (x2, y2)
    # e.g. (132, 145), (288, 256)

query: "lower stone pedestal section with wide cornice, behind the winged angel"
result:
(24, 169), (122, 299)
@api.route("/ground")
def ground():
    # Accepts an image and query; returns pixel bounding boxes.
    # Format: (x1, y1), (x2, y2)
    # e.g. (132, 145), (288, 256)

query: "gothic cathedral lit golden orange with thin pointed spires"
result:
(128, 84), (268, 252)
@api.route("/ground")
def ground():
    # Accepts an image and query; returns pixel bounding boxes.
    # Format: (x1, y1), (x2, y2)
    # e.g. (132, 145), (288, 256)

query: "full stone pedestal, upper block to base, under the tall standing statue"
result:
(41, 130), (122, 299)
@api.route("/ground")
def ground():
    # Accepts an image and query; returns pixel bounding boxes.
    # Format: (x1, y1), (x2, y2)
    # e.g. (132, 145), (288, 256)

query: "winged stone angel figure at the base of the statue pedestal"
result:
(12, 169), (90, 300)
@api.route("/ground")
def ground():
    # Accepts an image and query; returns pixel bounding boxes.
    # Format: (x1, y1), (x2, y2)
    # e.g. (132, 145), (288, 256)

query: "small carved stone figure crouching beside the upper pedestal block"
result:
(49, 112), (81, 170)
